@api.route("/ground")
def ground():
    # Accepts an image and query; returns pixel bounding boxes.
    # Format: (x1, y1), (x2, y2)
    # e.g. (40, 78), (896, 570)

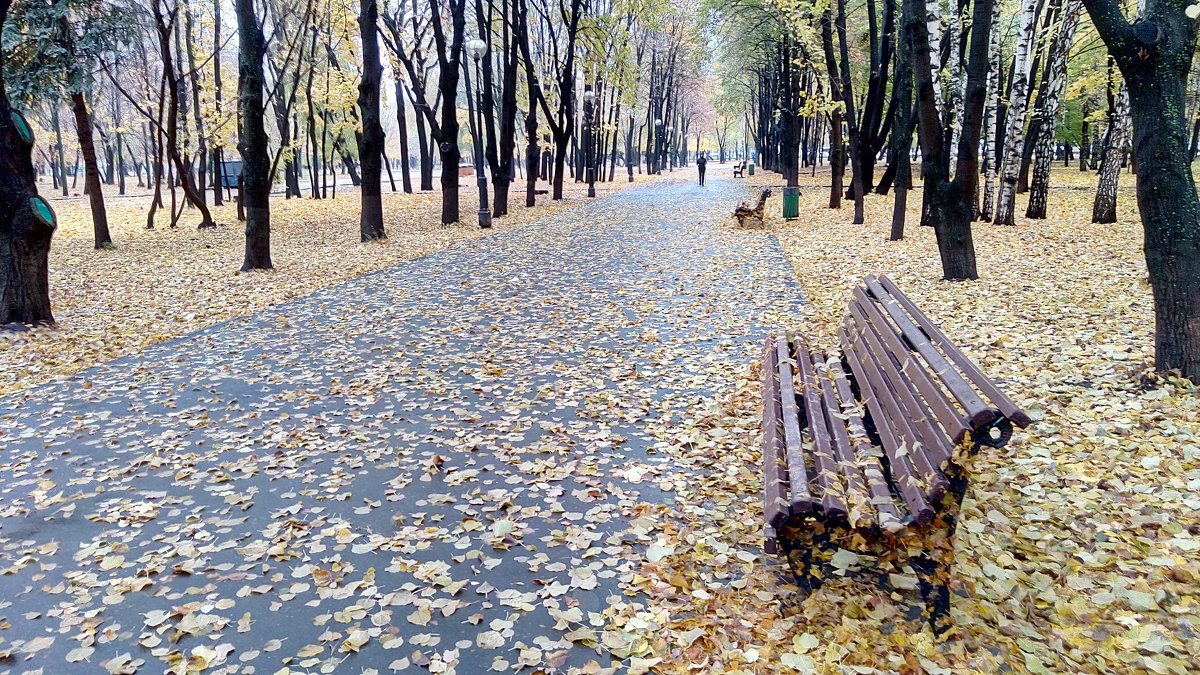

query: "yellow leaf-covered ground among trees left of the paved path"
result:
(0, 174), (649, 394)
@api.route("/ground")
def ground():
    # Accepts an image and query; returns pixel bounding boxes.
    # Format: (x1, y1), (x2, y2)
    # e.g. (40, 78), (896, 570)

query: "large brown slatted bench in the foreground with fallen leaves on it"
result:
(761, 276), (1030, 632)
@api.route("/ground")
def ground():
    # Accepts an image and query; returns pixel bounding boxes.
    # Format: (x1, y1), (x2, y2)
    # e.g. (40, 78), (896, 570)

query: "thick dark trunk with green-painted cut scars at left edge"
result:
(0, 0), (55, 328)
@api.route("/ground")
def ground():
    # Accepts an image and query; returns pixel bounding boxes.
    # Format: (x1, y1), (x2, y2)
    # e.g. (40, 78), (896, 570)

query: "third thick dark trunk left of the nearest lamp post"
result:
(234, 0), (272, 271)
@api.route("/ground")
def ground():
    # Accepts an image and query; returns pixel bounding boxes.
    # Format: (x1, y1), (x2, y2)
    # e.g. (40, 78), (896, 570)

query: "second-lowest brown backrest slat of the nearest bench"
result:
(850, 303), (953, 502)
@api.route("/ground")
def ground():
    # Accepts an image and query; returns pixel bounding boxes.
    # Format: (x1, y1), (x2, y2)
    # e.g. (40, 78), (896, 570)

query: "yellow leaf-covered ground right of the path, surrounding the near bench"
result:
(646, 165), (1200, 674)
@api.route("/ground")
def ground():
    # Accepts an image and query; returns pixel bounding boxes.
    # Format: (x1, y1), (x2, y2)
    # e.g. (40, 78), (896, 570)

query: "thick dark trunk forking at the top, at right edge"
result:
(1084, 0), (1200, 382)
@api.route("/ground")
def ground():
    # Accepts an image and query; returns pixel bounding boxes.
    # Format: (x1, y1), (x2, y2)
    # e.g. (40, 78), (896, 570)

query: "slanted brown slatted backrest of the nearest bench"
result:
(838, 276), (1030, 522)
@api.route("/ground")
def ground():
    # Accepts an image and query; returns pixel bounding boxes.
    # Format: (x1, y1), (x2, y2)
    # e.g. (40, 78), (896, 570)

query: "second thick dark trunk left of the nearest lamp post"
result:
(359, 0), (384, 241)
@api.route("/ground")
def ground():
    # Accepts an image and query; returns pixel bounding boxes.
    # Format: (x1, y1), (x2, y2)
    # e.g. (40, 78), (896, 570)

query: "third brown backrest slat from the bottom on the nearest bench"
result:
(851, 289), (968, 468)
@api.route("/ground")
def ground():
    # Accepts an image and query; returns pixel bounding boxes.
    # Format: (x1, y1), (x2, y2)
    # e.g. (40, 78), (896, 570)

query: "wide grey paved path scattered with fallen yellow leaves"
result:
(0, 173), (802, 674)
